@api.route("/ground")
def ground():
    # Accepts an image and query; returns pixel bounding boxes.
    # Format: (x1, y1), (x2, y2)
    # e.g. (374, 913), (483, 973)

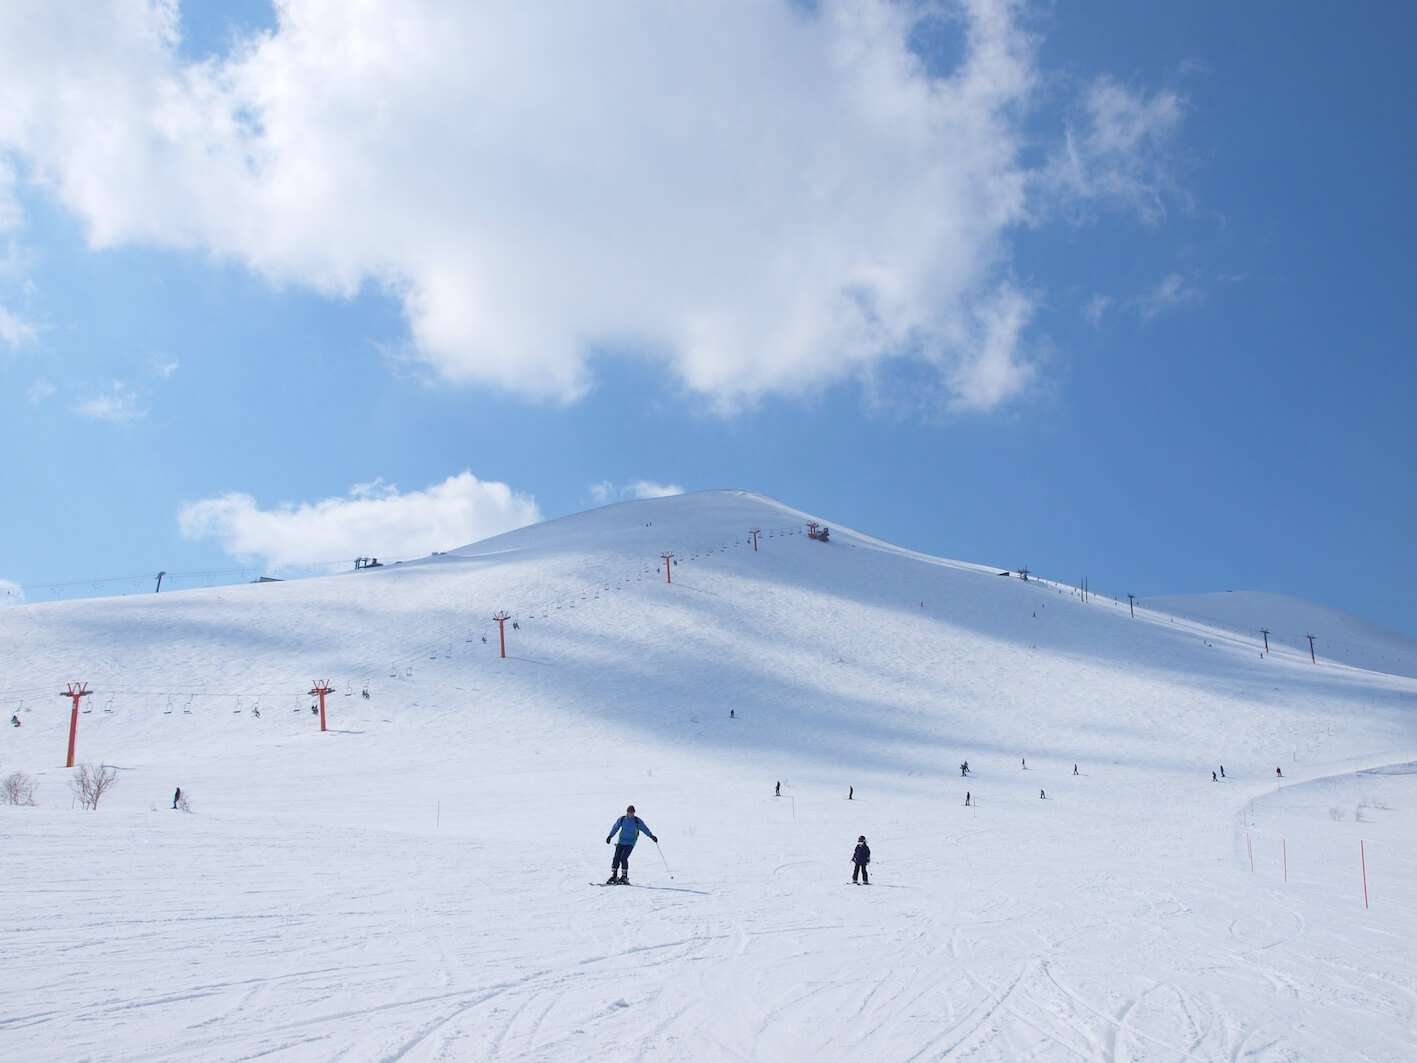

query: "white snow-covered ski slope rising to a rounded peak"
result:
(0, 492), (1417, 1063)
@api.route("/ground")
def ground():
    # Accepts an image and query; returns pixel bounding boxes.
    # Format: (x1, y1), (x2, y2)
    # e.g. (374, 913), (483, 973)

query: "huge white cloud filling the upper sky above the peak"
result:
(0, 0), (1179, 408)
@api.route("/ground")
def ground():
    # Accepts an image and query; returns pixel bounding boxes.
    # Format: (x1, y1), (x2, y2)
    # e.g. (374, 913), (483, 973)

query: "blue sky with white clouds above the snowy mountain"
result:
(0, 0), (1417, 635)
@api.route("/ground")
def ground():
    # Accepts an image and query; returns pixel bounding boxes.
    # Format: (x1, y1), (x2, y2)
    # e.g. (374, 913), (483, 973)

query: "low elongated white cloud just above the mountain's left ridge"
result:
(177, 471), (541, 567)
